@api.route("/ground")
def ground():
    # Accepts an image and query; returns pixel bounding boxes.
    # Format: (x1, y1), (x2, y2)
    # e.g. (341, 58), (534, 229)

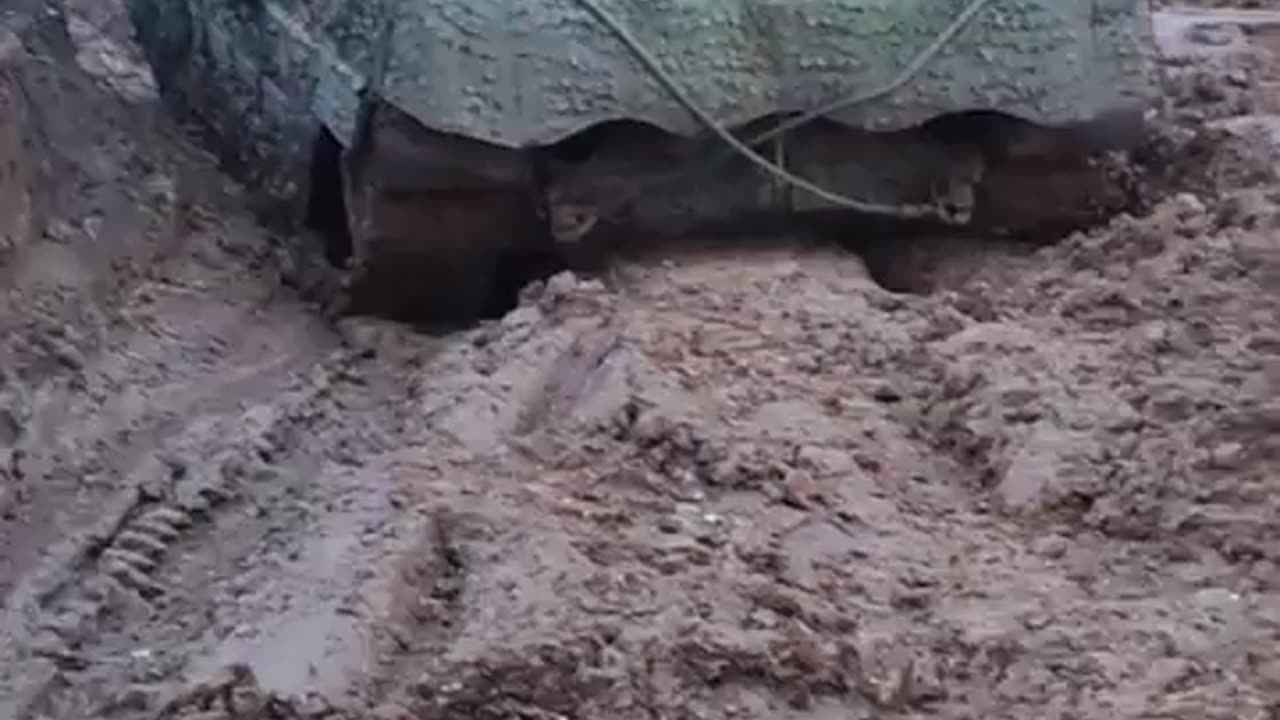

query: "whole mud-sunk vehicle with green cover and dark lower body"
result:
(129, 0), (1155, 319)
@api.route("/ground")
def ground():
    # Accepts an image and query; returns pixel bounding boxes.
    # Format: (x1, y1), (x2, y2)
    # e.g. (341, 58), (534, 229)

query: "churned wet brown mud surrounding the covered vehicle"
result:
(0, 3), (1280, 720)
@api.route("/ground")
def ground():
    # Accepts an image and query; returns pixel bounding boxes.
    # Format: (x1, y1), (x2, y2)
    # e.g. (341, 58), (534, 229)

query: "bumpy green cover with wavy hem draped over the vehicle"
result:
(132, 0), (1151, 146)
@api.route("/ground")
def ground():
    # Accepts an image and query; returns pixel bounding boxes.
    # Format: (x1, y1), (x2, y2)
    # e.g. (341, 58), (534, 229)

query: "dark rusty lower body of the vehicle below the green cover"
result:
(327, 108), (1140, 324)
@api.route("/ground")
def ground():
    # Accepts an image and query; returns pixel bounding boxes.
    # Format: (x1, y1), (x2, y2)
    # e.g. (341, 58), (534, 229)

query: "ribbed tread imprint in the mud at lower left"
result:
(5, 343), (389, 717)
